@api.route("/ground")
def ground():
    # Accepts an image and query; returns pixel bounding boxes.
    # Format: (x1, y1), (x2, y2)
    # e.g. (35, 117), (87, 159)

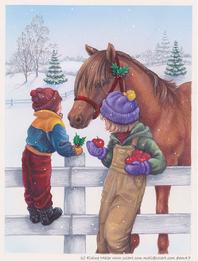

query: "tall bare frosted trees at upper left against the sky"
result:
(9, 15), (50, 82)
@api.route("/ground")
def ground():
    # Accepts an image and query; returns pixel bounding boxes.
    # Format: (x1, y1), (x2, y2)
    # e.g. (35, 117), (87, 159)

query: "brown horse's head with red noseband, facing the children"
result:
(68, 44), (119, 129)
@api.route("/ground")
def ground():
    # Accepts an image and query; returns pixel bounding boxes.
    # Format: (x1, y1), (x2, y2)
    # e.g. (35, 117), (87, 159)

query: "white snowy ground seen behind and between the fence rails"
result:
(5, 62), (191, 252)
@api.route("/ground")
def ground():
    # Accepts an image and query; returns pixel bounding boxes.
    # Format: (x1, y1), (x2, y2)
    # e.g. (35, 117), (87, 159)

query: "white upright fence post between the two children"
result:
(64, 153), (86, 253)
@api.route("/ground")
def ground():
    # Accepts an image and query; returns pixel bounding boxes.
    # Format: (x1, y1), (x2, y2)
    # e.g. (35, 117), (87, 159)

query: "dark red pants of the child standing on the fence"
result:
(22, 148), (52, 209)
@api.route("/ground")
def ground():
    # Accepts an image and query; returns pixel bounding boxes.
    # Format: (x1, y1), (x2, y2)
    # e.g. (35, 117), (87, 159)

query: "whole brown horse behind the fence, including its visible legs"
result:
(68, 44), (191, 254)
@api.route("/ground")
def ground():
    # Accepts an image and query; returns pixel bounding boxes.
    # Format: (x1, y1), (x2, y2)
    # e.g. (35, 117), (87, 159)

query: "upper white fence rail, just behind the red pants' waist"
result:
(5, 167), (191, 187)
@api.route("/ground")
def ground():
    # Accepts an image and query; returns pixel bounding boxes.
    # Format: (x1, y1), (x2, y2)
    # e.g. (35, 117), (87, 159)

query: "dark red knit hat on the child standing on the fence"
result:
(30, 88), (62, 112)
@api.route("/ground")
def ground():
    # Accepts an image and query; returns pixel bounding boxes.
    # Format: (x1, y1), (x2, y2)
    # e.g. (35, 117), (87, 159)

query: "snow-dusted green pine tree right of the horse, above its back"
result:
(165, 41), (187, 76)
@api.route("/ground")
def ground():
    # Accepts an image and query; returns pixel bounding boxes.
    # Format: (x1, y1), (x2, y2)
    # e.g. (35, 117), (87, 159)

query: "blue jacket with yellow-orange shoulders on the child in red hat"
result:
(26, 110), (75, 157)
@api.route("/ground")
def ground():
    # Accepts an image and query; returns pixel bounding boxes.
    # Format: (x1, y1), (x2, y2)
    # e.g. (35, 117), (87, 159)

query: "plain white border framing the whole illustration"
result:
(0, 0), (198, 261)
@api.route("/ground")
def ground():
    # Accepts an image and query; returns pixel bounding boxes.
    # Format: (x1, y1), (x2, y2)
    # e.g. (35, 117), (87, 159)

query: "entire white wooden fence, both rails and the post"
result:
(5, 155), (191, 253)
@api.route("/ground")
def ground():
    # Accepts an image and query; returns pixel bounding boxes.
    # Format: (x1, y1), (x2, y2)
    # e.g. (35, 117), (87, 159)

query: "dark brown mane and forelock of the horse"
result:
(75, 50), (177, 104)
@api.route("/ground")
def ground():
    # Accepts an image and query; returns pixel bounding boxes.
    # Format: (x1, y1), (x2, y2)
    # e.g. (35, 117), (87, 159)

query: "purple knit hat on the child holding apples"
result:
(100, 91), (140, 125)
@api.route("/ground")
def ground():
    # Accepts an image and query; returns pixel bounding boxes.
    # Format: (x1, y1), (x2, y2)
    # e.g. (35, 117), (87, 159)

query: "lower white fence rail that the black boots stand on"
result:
(6, 213), (190, 236)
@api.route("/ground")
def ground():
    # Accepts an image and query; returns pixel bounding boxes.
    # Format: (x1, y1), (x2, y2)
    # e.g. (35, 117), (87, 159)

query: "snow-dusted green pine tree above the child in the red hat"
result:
(44, 50), (67, 85)
